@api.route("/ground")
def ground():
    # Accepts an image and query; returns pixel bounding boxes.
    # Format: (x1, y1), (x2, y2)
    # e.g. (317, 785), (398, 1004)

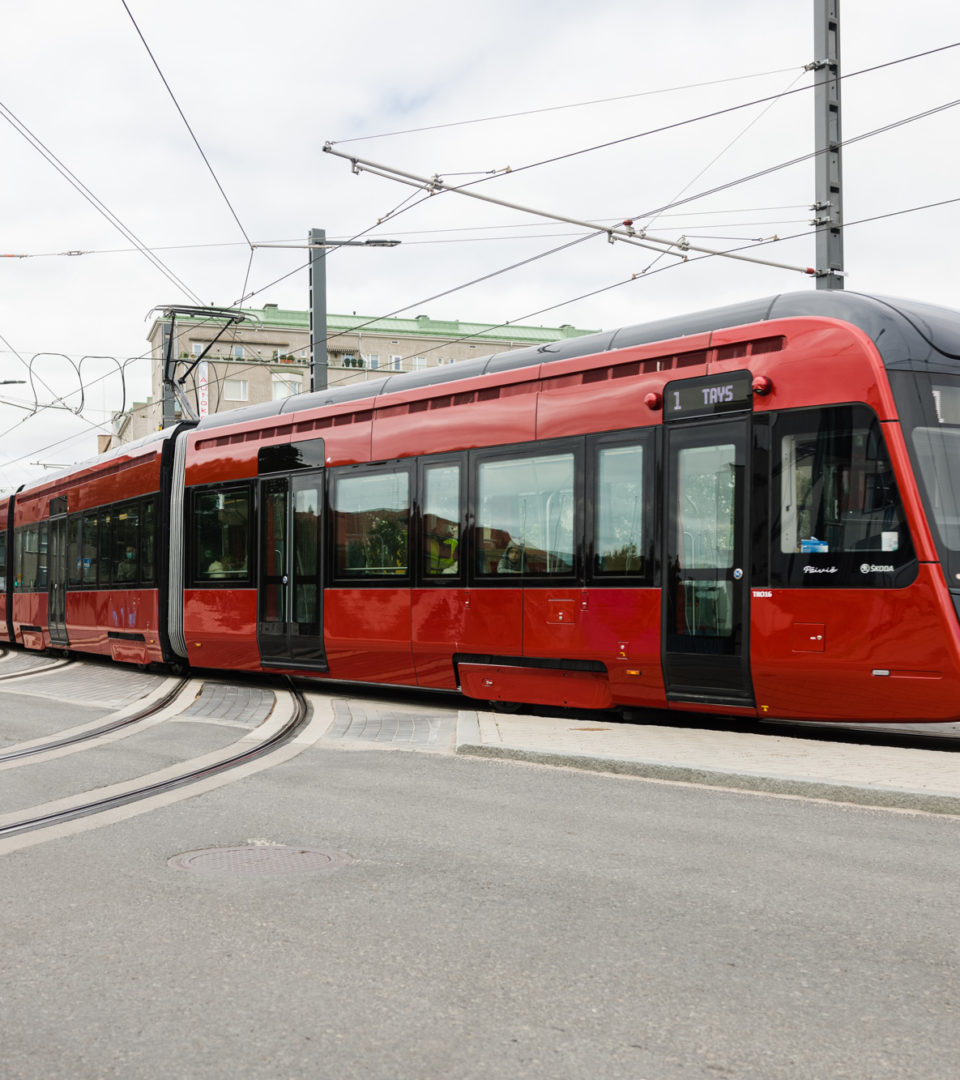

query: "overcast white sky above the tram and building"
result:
(0, 0), (960, 487)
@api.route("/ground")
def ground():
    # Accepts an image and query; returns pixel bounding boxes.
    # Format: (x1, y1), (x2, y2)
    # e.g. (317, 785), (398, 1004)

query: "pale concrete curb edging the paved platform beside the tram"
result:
(457, 711), (960, 816)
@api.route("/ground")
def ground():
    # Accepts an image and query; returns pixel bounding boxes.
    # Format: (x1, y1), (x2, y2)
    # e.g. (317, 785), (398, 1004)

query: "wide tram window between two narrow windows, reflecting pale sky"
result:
(476, 454), (574, 576)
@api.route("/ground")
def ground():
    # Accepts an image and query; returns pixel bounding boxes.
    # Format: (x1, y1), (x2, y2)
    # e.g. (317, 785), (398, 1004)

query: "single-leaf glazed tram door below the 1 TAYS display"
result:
(663, 418), (754, 705)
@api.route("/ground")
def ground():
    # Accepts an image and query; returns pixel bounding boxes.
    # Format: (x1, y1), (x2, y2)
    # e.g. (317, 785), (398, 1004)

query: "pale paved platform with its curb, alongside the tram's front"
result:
(457, 711), (960, 814)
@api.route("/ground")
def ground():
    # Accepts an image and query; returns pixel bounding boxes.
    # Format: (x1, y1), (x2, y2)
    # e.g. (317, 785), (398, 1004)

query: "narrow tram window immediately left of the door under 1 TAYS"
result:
(594, 446), (644, 575)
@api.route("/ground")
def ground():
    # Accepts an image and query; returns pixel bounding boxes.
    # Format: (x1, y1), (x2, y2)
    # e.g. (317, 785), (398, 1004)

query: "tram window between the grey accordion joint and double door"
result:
(193, 485), (251, 584)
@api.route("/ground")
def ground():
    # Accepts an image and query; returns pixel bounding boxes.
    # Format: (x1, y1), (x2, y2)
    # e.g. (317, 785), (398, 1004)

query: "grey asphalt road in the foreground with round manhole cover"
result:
(0, 682), (960, 1080)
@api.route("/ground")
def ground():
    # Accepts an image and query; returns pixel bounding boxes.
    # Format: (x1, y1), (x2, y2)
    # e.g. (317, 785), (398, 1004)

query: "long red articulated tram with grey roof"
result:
(0, 292), (960, 723)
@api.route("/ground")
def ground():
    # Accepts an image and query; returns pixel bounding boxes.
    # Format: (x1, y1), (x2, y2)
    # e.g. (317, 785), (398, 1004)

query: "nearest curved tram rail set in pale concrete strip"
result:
(0, 681), (309, 840)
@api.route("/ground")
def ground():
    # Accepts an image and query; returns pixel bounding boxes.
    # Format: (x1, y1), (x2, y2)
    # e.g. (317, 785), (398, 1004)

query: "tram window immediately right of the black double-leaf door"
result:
(334, 470), (410, 578)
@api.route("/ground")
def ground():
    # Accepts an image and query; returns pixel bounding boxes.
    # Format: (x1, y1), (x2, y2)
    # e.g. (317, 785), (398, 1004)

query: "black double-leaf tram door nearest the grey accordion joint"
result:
(257, 470), (326, 670)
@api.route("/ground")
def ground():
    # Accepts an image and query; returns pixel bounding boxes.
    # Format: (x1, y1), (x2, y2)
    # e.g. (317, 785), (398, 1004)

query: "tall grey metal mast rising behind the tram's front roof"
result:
(808, 0), (843, 288)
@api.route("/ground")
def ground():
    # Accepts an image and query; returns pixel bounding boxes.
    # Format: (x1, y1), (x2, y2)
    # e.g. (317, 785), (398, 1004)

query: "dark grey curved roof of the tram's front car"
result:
(198, 289), (960, 430)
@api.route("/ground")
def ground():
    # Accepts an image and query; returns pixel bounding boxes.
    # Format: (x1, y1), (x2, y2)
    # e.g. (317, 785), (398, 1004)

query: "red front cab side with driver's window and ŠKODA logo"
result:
(751, 320), (960, 721)
